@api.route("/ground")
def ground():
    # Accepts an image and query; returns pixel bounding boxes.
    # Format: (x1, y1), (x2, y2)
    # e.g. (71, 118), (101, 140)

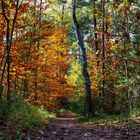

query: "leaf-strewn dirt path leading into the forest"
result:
(26, 113), (140, 140)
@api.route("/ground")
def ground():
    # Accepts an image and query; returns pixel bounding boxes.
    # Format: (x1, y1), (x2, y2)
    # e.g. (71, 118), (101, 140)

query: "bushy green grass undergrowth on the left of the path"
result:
(0, 99), (55, 130)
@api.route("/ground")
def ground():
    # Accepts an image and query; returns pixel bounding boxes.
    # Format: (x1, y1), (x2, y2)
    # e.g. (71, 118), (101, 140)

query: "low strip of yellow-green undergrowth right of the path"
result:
(77, 108), (140, 126)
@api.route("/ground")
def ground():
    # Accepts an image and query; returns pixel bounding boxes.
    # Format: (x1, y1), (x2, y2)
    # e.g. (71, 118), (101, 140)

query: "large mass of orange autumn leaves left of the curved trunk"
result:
(0, 0), (71, 109)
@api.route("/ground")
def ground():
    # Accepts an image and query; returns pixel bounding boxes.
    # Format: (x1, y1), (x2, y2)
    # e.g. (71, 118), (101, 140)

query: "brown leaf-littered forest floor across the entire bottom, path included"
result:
(0, 113), (140, 140)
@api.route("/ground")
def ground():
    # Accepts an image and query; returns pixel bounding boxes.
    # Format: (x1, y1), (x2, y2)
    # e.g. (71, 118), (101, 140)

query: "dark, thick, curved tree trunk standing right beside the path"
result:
(72, 0), (94, 116)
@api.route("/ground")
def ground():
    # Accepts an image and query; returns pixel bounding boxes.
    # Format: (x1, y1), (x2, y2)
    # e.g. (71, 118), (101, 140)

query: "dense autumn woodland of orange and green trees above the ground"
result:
(0, 0), (140, 139)
